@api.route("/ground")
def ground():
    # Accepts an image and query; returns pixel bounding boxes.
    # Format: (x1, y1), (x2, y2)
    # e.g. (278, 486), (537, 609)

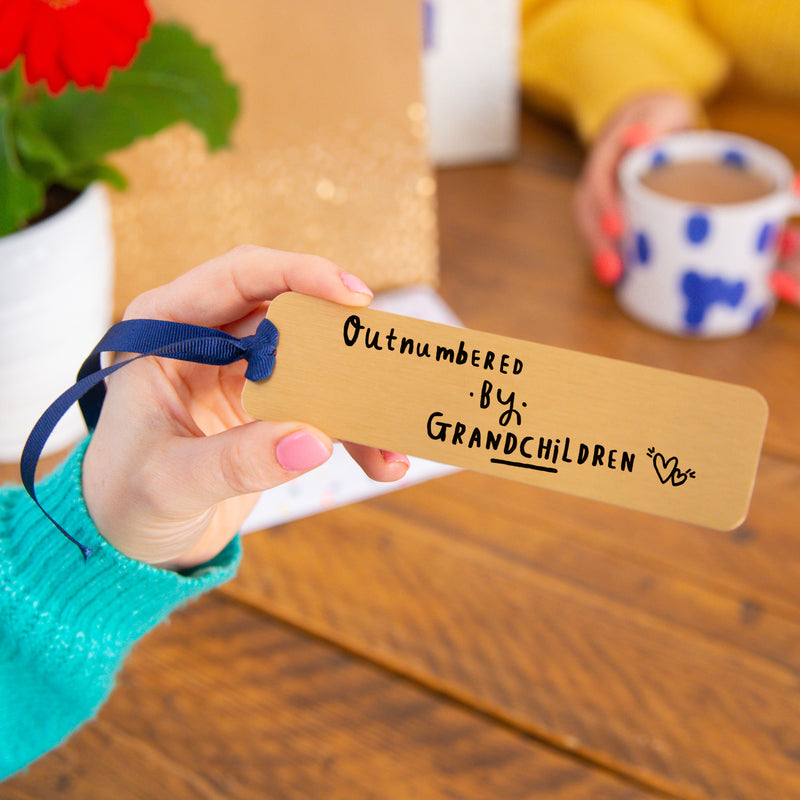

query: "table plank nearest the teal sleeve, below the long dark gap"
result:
(0, 597), (650, 800)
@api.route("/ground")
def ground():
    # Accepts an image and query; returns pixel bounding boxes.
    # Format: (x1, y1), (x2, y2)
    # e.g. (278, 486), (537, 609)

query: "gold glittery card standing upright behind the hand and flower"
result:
(112, 0), (437, 316)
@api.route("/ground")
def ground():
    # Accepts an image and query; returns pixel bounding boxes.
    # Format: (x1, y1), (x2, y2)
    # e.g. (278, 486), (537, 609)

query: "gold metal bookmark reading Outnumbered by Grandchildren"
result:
(242, 293), (768, 530)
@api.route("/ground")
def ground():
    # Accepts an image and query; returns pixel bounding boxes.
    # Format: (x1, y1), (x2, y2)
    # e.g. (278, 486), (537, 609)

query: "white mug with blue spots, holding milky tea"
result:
(616, 131), (800, 337)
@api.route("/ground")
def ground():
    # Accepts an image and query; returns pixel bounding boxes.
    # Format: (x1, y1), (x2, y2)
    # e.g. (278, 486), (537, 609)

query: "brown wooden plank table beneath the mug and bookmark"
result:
(6, 104), (800, 800)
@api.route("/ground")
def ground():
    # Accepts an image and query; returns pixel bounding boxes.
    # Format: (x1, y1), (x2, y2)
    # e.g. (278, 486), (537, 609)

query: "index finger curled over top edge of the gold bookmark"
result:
(125, 245), (372, 327)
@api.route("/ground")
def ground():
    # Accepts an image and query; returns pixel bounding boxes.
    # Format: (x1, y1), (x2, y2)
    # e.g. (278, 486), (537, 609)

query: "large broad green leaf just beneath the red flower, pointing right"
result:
(21, 24), (238, 169)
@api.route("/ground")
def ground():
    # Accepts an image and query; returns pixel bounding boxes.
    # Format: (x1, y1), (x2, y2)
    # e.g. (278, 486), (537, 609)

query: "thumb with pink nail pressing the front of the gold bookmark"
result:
(178, 420), (333, 508)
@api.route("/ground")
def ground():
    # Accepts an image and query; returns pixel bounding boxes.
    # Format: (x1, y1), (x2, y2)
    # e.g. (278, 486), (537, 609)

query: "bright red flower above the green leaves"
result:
(0, 0), (152, 94)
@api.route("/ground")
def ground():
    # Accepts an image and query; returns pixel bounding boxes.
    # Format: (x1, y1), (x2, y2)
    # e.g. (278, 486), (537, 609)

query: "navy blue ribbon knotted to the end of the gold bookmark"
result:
(20, 319), (278, 559)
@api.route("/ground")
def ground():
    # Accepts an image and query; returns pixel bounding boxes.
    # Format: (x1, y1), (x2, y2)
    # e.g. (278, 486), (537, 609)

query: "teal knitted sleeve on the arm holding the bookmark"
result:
(0, 440), (240, 780)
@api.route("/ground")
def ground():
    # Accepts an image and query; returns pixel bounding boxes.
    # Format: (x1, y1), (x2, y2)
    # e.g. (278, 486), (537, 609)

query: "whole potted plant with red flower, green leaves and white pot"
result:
(0, 0), (238, 461)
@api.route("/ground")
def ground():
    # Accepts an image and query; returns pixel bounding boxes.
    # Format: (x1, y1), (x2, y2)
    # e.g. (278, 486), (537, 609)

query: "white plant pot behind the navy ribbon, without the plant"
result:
(0, 184), (114, 462)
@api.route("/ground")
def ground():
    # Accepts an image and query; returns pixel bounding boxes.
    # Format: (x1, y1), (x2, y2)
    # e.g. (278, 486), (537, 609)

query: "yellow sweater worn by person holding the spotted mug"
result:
(520, 0), (800, 140)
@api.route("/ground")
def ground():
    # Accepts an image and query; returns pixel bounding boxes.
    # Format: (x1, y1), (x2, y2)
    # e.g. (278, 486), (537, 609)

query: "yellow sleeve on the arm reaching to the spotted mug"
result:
(519, 0), (729, 140)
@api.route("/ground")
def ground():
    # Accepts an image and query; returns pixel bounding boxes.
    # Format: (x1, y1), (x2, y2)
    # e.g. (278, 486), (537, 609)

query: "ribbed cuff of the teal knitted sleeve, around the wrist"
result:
(0, 438), (240, 674)
